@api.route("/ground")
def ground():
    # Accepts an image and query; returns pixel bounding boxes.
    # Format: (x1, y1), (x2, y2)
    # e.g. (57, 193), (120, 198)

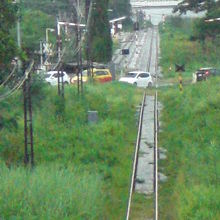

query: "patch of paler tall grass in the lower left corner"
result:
(0, 164), (105, 220)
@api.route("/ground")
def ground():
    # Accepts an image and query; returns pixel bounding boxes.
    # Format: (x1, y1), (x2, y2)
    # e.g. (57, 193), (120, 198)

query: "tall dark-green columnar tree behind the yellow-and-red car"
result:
(90, 0), (112, 63)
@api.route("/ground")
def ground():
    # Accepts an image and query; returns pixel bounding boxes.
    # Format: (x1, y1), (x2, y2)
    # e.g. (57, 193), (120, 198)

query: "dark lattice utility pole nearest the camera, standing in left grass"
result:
(23, 61), (34, 168)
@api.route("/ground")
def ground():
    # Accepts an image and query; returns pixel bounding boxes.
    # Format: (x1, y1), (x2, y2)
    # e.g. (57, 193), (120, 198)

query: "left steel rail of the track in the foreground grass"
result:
(126, 92), (146, 220)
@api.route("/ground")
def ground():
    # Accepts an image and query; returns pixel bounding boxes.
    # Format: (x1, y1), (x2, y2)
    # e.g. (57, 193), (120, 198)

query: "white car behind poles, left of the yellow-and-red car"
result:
(44, 71), (70, 86)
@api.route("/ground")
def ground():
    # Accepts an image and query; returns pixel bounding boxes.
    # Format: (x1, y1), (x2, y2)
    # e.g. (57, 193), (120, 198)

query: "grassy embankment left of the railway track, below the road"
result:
(0, 83), (142, 219)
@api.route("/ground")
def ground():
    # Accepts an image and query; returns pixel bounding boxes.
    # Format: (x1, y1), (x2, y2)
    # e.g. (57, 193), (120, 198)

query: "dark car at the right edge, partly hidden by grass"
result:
(193, 67), (220, 83)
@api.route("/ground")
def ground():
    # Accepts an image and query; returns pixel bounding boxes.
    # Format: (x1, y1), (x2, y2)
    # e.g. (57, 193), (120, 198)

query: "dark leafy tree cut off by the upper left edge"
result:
(0, 0), (18, 81)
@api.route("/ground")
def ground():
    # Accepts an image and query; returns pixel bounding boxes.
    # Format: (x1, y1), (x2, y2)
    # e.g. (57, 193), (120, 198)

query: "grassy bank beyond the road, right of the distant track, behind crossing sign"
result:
(160, 17), (220, 82)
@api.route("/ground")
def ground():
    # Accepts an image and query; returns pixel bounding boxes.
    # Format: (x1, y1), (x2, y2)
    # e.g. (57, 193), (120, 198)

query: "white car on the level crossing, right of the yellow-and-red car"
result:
(119, 71), (153, 87)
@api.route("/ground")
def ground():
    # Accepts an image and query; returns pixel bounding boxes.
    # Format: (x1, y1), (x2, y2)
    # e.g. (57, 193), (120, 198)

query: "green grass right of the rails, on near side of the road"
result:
(159, 78), (220, 220)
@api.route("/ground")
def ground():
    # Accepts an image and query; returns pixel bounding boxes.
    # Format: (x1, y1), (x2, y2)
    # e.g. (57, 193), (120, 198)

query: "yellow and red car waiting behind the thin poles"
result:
(71, 68), (112, 83)
